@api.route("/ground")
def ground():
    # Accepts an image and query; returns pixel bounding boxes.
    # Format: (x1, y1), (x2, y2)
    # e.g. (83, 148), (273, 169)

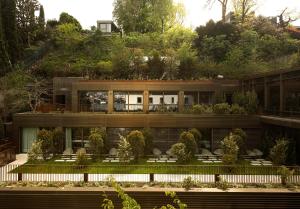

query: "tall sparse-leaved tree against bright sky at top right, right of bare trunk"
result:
(232, 0), (256, 24)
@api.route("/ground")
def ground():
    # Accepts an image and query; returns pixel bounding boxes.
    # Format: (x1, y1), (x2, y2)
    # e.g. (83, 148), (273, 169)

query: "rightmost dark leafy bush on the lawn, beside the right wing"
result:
(270, 138), (289, 165)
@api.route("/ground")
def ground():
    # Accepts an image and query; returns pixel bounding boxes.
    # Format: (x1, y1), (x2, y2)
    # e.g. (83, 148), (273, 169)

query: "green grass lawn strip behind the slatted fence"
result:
(12, 159), (300, 175)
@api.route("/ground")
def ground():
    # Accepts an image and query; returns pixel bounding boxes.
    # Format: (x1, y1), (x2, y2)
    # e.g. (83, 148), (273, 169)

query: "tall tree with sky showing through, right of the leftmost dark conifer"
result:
(16, 0), (39, 47)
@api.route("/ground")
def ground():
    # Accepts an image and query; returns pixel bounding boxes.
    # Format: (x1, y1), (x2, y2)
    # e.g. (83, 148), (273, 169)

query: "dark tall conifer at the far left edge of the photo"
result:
(1, 0), (19, 68)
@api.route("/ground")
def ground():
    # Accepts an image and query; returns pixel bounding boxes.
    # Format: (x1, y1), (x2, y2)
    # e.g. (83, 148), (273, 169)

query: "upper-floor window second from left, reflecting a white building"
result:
(114, 91), (143, 112)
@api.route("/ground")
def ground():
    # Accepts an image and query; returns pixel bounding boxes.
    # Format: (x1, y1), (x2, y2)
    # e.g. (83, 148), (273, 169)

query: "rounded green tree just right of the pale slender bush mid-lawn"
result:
(126, 130), (145, 161)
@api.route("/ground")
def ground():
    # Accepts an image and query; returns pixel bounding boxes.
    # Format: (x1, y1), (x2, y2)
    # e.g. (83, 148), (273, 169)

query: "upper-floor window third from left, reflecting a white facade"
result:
(149, 91), (178, 112)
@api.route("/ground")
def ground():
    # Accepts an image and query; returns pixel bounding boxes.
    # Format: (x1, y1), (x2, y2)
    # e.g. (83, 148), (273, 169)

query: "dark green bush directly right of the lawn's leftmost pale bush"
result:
(37, 129), (53, 160)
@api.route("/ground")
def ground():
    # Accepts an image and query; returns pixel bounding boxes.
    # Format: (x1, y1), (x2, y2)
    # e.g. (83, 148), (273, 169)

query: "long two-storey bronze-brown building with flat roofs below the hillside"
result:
(14, 70), (300, 163)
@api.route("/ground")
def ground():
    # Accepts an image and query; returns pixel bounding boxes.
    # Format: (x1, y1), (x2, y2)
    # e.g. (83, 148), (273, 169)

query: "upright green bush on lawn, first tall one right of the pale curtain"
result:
(88, 128), (104, 160)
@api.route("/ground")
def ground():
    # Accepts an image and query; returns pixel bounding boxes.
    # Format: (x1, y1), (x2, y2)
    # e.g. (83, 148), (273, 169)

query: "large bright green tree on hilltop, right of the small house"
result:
(113, 0), (184, 33)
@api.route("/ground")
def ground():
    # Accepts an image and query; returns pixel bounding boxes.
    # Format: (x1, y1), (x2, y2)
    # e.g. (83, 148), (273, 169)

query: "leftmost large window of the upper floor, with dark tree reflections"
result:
(79, 91), (108, 112)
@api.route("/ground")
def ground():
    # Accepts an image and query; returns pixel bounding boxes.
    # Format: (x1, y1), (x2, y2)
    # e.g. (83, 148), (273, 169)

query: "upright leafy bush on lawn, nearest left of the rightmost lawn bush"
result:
(221, 133), (239, 165)
